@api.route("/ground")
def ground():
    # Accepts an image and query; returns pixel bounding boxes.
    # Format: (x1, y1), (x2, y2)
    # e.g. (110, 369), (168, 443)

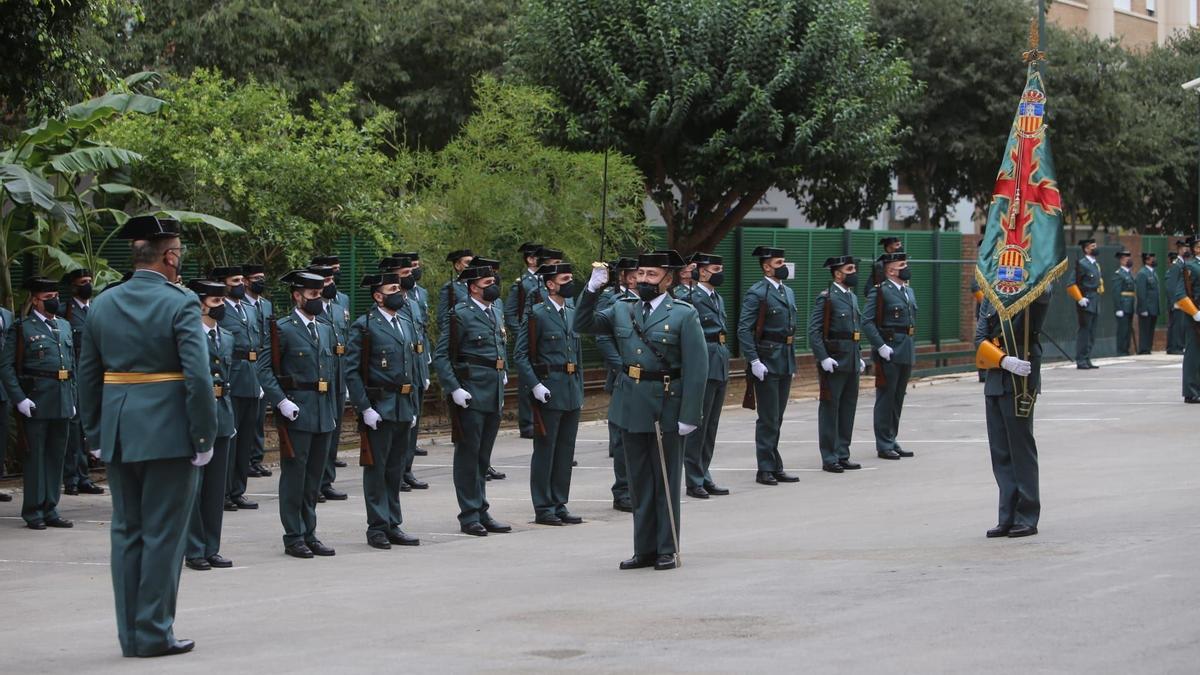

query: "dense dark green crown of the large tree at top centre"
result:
(512, 0), (912, 251)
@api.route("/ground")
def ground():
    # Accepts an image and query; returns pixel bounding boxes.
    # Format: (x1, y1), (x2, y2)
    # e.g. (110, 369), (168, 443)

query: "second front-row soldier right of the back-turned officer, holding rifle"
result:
(258, 269), (341, 558)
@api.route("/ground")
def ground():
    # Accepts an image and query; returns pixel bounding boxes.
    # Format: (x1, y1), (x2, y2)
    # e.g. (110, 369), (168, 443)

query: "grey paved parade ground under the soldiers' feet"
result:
(0, 354), (1200, 674)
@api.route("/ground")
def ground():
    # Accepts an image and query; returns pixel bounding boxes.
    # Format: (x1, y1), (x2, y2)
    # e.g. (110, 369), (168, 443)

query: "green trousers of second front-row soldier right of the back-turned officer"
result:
(280, 430), (332, 546)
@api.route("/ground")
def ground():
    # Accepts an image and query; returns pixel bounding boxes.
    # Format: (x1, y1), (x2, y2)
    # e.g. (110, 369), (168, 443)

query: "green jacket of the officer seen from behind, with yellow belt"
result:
(78, 269), (217, 462)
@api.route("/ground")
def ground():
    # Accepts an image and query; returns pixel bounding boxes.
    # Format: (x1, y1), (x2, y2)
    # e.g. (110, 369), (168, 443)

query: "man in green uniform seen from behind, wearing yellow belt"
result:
(79, 216), (217, 657)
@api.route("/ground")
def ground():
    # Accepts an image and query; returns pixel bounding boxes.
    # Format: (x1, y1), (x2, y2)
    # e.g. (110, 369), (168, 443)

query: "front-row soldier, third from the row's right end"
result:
(738, 246), (799, 485)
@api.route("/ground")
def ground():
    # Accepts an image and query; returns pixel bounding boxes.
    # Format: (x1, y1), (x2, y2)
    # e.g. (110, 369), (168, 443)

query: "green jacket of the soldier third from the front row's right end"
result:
(738, 279), (796, 375)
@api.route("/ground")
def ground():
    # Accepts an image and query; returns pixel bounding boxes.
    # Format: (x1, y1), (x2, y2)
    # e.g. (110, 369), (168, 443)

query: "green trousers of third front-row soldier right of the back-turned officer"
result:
(362, 419), (412, 534)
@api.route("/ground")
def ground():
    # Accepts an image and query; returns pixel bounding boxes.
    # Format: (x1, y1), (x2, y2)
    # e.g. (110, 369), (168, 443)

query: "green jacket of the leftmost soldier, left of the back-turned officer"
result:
(0, 311), (76, 419)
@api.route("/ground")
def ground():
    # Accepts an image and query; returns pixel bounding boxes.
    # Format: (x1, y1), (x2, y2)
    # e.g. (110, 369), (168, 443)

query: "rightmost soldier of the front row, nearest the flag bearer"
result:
(864, 253), (917, 458)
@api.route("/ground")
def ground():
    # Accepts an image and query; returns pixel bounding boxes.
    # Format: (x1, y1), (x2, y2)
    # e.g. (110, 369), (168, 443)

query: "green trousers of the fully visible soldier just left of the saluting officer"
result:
(529, 401), (580, 518)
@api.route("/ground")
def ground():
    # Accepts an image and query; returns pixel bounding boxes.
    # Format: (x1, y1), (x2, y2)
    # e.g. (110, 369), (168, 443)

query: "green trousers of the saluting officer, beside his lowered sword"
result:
(623, 431), (681, 556)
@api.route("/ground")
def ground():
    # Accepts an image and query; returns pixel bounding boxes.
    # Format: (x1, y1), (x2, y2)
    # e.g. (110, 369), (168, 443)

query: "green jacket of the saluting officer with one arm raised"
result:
(575, 291), (708, 434)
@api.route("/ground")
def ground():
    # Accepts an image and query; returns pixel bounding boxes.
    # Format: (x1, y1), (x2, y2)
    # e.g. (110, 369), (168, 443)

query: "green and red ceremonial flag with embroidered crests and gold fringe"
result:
(976, 62), (1067, 321)
